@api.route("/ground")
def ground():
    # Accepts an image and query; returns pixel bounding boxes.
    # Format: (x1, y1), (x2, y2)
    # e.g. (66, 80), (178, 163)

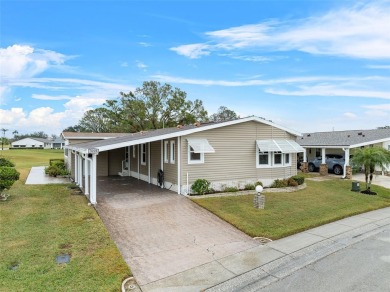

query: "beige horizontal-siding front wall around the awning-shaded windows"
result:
(181, 122), (297, 188)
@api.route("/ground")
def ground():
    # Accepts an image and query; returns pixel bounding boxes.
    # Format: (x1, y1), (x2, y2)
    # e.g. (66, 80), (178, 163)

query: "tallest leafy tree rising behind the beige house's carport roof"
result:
(120, 81), (208, 131)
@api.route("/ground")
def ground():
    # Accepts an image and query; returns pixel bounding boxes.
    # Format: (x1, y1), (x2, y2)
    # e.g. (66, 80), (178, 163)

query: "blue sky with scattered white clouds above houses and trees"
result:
(0, 0), (390, 136)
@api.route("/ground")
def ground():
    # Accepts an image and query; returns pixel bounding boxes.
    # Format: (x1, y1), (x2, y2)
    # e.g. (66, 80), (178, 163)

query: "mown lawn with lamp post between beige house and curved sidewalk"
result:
(194, 179), (390, 239)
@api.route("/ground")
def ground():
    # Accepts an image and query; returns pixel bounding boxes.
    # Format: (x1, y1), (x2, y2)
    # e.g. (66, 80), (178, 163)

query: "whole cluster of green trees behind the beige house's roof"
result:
(64, 81), (239, 133)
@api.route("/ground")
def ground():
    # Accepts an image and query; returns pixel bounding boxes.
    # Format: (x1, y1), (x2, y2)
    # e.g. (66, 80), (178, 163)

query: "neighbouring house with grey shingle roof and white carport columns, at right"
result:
(296, 129), (390, 177)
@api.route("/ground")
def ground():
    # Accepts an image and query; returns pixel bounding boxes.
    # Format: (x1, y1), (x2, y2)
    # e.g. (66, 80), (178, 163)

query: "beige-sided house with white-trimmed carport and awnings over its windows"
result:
(64, 117), (304, 203)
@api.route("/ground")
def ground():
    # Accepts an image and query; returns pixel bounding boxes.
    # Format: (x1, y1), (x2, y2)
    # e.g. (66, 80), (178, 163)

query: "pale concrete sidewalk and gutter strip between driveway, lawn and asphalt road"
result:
(142, 208), (390, 292)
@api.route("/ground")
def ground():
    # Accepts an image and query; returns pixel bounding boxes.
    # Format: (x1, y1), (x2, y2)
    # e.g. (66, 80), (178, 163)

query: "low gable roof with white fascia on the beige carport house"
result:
(66, 116), (301, 152)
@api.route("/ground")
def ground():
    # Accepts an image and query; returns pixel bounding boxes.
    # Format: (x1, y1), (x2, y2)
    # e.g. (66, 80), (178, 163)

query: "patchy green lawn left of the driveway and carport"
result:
(0, 149), (131, 291)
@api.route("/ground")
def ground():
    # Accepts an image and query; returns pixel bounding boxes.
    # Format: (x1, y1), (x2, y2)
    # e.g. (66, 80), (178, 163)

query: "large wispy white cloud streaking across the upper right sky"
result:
(171, 1), (390, 59)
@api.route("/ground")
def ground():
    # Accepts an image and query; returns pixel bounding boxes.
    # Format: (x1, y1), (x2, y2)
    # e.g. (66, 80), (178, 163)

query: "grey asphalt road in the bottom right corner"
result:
(258, 226), (390, 292)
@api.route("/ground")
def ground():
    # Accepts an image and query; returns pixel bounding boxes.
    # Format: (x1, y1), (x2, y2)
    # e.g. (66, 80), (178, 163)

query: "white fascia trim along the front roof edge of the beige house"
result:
(96, 117), (302, 152)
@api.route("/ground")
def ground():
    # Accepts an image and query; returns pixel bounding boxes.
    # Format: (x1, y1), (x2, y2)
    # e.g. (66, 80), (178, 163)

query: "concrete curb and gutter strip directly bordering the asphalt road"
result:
(205, 214), (390, 292)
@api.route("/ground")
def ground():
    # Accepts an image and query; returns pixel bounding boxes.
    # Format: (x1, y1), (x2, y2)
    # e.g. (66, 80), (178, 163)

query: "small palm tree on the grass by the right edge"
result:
(352, 147), (390, 191)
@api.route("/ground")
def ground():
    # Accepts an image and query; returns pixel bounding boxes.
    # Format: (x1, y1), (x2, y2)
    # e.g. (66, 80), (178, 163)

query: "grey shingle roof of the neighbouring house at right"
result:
(297, 129), (390, 148)
